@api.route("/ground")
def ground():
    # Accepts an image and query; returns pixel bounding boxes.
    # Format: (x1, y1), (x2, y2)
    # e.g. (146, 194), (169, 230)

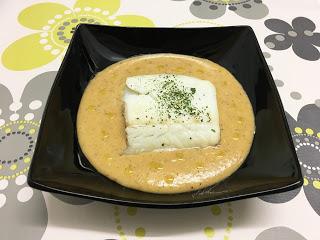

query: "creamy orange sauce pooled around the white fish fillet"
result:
(77, 54), (255, 193)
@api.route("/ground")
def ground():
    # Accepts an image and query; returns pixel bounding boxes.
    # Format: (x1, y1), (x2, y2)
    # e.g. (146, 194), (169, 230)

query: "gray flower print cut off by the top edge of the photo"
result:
(175, 0), (269, 19)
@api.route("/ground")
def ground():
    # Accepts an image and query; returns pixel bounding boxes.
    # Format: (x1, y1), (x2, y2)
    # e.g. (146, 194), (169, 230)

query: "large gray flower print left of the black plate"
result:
(0, 72), (92, 240)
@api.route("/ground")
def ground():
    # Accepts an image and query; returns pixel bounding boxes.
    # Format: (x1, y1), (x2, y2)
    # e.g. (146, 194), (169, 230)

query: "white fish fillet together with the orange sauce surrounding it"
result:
(77, 53), (255, 193)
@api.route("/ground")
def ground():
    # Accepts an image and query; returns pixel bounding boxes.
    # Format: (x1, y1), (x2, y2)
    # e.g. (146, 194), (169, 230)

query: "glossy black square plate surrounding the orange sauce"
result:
(28, 25), (302, 208)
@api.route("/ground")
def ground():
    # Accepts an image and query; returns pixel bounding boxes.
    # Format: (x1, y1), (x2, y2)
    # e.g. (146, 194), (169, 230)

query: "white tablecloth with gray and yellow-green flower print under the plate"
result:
(0, 0), (320, 240)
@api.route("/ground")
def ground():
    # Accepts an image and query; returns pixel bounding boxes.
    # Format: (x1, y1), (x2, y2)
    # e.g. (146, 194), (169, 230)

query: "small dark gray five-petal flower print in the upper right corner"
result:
(264, 17), (320, 61)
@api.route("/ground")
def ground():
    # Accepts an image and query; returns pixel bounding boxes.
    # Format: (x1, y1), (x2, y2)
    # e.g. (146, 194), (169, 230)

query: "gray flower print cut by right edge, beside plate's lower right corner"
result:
(260, 104), (320, 215)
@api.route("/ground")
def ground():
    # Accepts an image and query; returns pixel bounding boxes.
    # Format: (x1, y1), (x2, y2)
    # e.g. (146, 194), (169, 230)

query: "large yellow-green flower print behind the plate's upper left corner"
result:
(1, 0), (154, 71)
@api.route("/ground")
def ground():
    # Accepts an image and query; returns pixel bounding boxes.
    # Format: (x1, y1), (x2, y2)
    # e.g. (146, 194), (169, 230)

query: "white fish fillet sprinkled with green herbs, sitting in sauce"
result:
(123, 74), (220, 154)
